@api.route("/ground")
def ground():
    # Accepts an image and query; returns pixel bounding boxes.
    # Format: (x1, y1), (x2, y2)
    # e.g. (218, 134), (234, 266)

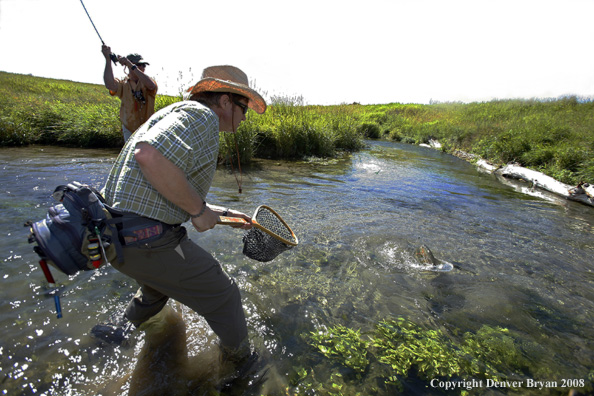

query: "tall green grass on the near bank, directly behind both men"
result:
(0, 72), (363, 163)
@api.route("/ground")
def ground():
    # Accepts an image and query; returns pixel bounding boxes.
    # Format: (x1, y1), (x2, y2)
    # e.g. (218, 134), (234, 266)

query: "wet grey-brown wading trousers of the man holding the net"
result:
(114, 227), (247, 349)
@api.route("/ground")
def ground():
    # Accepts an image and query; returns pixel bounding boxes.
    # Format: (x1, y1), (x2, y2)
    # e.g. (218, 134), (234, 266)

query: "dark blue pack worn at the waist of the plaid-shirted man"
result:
(25, 182), (123, 276)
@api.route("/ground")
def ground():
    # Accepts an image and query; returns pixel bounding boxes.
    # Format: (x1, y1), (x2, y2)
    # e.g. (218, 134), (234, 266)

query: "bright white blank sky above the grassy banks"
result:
(0, 0), (594, 105)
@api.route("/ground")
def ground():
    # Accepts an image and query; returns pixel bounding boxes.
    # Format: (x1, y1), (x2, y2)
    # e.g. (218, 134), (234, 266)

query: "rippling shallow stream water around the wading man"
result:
(0, 142), (594, 395)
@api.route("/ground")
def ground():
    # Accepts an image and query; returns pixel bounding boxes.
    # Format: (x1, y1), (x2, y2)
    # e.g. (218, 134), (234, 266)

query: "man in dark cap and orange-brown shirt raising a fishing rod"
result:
(101, 45), (157, 141)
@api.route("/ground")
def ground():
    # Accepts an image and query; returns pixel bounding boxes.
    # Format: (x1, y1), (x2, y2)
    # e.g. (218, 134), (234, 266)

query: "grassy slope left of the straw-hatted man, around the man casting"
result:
(0, 72), (179, 147)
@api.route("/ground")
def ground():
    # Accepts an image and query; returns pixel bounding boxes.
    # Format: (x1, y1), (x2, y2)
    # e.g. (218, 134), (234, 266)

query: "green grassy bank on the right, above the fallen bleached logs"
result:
(362, 97), (594, 184)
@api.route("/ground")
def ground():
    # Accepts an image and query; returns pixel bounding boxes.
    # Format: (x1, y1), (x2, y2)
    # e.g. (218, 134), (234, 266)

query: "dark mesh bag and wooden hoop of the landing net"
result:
(243, 207), (297, 262)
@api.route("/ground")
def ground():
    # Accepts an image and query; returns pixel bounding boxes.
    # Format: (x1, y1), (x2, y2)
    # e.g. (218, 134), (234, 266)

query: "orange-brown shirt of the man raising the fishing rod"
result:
(109, 78), (157, 132)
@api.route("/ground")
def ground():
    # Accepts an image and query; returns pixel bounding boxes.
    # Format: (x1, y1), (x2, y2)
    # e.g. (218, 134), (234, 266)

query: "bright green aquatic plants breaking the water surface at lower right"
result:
(308, 318), (538, 389)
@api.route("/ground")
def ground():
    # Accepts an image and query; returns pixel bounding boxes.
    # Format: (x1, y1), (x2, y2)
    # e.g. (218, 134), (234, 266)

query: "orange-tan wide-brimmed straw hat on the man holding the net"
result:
(188, 66), (266, 114)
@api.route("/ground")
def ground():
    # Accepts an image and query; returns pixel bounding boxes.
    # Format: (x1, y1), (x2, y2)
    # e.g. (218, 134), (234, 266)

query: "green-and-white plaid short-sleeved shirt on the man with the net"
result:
(104, 101), (219, 224)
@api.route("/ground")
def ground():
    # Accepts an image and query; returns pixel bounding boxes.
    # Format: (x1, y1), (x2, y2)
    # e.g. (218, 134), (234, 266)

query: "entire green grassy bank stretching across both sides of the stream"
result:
(0, 72), (594, 184)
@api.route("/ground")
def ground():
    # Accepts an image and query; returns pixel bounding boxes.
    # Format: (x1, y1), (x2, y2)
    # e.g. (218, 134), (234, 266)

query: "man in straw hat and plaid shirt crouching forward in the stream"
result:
(93, 66), (266, 372)
